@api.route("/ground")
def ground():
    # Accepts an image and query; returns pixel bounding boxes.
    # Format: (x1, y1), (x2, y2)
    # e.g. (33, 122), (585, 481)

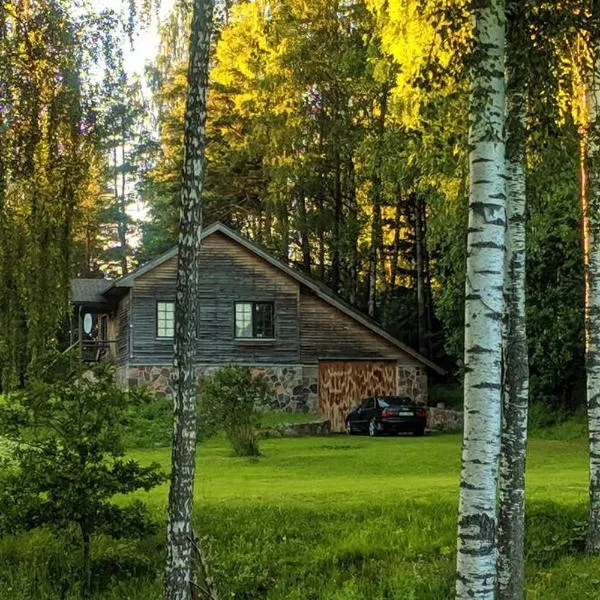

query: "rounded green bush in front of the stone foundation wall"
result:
(198, 366), (270, 456)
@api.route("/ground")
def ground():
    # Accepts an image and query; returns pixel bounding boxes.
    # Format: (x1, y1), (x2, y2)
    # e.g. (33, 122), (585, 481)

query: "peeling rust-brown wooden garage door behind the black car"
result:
(319, 360), (397, 432)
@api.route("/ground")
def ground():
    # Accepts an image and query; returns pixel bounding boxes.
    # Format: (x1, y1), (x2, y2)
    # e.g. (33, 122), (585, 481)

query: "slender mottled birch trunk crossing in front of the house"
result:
(164, 0), (213, 600)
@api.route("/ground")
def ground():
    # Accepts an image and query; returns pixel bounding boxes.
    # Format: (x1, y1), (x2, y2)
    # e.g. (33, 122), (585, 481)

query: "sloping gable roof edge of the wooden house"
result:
(108, 222), (446, 375)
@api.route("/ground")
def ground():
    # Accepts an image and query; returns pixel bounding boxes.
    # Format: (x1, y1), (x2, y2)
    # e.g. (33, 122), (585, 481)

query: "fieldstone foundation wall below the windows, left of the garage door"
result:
(118, 365), (319, 412)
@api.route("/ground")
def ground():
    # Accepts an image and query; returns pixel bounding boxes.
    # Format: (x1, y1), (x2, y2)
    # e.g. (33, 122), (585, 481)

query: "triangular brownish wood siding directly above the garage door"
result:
(300, 289), (419, 365)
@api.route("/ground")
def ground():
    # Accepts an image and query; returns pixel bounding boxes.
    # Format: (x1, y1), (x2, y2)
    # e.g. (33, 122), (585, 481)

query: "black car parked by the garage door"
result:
(346, 396), (427, 436)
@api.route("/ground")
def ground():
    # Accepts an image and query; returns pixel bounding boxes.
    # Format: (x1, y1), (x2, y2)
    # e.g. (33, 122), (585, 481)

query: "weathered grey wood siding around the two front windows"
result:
(132, 233), (299, 364)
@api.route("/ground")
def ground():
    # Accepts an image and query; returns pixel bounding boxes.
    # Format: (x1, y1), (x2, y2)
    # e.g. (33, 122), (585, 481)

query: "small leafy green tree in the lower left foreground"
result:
(0, 354), (165, 596)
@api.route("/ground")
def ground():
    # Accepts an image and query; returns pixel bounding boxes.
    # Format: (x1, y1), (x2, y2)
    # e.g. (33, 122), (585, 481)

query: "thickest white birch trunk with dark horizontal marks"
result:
(456, 0), (506, 600)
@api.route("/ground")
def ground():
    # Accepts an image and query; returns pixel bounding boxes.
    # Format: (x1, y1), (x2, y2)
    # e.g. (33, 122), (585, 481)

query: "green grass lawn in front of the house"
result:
(0, 435), (600, 600)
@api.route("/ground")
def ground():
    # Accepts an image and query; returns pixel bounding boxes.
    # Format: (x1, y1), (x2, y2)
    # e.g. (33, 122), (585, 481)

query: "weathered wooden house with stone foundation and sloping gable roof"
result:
(72, 223), (443, 430)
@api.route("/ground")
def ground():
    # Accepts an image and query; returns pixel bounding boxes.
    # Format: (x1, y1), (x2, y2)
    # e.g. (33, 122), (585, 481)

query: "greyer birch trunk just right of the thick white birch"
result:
(497, 54), (529, 600)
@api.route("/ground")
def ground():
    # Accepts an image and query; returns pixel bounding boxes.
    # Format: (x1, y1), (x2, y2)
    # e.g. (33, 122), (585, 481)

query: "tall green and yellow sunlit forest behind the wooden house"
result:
(0, 2), (585, 411)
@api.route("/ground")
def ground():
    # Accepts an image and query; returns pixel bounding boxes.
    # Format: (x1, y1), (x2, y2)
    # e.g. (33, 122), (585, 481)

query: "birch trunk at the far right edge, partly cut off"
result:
(581, 59), (600, 554)
